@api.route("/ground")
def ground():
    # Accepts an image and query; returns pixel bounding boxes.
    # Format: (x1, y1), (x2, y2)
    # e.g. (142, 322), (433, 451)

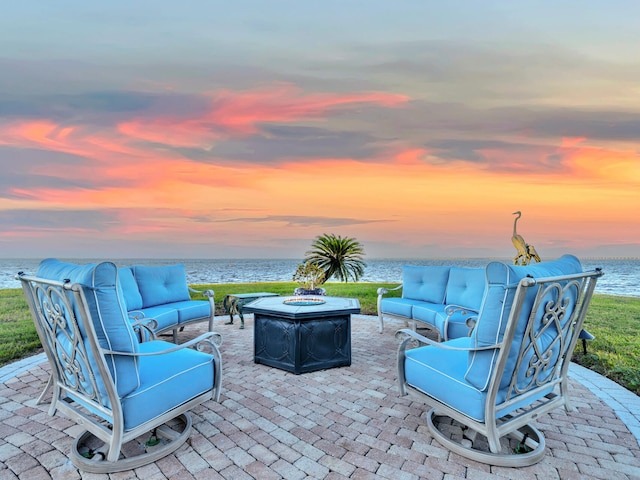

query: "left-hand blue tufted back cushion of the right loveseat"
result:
(402, 265), (451, 303)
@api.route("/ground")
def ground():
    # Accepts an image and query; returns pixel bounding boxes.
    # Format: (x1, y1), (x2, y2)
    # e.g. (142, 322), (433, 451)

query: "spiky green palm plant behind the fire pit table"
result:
(305, 233), (367, 282)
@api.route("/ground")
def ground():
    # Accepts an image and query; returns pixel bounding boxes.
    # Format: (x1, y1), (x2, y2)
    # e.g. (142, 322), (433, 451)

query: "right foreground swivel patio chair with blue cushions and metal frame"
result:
(397, 255), (603, 467)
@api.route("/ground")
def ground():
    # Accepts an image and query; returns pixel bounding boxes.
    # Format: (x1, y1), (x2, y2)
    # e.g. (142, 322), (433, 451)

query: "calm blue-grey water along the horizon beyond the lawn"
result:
(0, 259), (640, 297)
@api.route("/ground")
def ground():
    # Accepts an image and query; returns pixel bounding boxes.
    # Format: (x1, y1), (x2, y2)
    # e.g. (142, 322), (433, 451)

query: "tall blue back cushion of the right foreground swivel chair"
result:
(465, 255), (582, 390)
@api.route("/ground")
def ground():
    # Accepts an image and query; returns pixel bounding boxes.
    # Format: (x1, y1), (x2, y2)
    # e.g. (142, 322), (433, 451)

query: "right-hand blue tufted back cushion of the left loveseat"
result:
(131, 265), (191, 308)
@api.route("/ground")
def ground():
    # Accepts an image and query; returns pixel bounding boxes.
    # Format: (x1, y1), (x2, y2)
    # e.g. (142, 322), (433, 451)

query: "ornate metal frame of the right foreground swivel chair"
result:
(397, 269), (603, 467)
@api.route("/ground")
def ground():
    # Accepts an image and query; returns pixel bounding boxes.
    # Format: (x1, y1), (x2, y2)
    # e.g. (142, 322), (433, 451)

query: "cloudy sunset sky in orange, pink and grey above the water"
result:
(0, 0), (640, 260)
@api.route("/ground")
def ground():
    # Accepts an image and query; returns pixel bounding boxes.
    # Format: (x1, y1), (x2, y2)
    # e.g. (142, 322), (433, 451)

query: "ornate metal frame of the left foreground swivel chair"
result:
(18, 275), (222, 473)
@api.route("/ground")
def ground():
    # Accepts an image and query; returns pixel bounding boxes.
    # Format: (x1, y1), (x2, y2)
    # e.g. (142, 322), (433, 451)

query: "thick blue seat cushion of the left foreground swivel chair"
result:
(122, 340), (214, 431)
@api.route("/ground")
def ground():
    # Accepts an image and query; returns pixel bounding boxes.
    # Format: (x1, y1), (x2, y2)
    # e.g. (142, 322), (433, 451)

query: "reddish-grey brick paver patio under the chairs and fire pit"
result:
(0, 315), (640, 480)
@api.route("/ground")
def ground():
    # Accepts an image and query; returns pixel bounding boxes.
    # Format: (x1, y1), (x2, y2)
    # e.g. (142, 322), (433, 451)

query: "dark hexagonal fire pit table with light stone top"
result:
(243, 296), (360, 374)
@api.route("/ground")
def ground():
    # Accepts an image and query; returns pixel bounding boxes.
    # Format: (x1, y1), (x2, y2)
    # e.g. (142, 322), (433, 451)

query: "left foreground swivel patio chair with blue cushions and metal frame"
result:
(18, 261), (222, 473)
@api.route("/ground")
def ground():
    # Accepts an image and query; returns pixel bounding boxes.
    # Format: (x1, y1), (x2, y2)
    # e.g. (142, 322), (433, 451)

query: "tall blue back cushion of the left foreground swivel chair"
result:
(36, 258), (139, 400)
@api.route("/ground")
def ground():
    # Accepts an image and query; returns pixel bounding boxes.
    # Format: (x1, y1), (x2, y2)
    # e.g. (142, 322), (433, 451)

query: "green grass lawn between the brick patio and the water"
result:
(0, 282), (640, 395)
